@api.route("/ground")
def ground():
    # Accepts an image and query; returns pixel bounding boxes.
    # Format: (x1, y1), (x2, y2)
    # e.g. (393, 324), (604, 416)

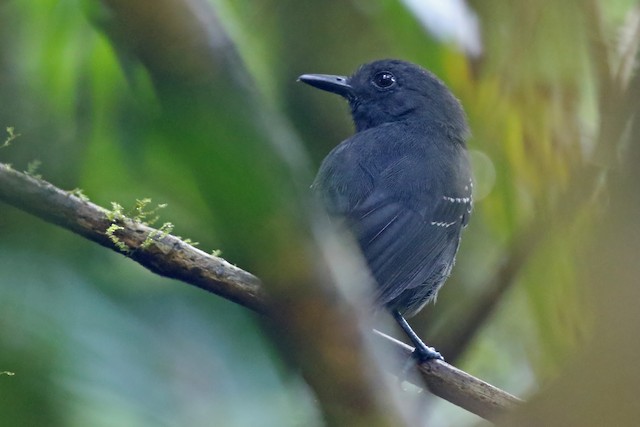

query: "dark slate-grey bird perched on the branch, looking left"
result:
(298, 59), (473, 362)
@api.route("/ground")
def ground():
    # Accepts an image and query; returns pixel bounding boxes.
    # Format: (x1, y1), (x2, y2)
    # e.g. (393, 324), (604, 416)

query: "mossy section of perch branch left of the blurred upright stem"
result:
(0, 163), (267, 313)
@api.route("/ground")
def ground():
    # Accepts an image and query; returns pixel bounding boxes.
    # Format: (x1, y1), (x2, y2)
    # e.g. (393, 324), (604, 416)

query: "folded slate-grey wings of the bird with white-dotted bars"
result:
(314, 135), (472, 312)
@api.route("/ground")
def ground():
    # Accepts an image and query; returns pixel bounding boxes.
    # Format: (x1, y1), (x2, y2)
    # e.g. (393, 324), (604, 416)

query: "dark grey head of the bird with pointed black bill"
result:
(298, 59), (467, 140)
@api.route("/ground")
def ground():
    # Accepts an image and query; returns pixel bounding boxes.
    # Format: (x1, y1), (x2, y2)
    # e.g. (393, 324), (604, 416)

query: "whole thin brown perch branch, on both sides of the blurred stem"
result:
(0, 163), (521, 420)
